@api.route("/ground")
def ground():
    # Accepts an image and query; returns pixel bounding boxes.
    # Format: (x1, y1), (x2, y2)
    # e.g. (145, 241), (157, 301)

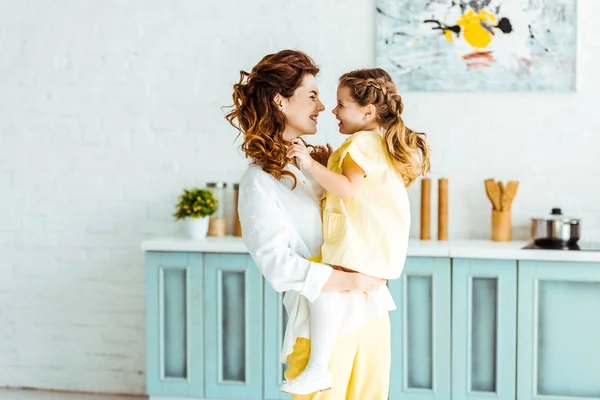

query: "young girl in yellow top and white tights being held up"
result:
(281, 68), (429, 395)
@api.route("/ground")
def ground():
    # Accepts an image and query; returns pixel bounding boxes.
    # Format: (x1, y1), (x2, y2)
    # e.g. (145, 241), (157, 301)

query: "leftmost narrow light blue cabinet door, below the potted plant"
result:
(146, 252), (204, 397)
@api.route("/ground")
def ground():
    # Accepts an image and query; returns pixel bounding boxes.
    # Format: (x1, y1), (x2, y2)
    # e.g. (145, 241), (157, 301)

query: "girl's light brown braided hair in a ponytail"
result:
(339, 68), (430, 186)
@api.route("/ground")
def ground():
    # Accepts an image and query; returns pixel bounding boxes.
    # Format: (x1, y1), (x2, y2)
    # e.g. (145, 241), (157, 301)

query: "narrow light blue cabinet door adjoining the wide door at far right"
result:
(452, 259), (517, 400)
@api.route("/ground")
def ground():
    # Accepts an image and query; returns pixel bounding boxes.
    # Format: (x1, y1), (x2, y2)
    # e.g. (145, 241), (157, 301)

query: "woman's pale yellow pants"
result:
(285, 315), (391, 400)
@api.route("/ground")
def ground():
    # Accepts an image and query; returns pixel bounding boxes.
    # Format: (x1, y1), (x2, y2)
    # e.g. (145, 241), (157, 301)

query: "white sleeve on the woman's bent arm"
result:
(238, 188), (333, 302)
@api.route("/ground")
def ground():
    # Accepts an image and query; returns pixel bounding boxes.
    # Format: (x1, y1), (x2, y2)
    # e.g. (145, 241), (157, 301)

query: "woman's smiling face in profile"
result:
(281, 75), (325, 140)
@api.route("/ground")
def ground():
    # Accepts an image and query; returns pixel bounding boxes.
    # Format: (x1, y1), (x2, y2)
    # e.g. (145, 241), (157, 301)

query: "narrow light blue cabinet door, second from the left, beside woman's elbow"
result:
(204, 254), (263, 400)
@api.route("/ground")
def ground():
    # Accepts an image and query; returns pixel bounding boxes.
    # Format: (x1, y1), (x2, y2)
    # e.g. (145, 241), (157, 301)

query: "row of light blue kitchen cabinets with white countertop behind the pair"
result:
(145, 238), (600, 400)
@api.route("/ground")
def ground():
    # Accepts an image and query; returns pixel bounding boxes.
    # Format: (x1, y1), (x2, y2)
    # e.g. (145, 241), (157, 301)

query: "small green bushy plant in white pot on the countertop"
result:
(173, 188), (219, 239)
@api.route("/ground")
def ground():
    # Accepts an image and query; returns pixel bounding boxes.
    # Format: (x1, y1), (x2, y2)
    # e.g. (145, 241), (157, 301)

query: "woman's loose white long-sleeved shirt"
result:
(238, 165), (395, 363)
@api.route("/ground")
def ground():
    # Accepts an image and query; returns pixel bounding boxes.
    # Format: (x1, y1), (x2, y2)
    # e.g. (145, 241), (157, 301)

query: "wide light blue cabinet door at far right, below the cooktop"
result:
(517, 261), (600, 400)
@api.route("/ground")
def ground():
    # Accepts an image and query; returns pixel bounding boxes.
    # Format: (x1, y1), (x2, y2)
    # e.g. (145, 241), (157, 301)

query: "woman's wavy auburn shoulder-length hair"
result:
(225, 50), (319, 187)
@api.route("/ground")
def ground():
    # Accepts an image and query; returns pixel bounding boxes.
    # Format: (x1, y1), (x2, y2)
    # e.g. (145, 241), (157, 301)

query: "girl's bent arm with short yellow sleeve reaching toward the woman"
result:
(287, 139), (365, 199)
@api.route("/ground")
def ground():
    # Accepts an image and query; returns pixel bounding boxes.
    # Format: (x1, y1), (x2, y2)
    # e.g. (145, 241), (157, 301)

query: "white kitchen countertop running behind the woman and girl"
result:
(142, 236), (600, 262)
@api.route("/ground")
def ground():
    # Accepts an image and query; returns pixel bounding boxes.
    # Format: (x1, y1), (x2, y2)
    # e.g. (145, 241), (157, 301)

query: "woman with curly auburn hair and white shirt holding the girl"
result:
(227, 50), (390, 400)
